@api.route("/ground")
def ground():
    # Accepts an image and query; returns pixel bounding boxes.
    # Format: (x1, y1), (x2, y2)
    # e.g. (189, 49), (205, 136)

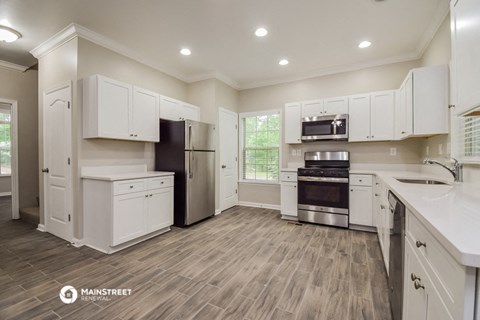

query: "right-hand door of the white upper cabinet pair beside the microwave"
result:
(370, 91), (395, 141)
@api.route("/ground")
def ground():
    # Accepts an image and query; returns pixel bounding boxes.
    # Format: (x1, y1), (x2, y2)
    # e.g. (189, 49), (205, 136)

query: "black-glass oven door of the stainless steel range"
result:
(298, 176), (349, 214)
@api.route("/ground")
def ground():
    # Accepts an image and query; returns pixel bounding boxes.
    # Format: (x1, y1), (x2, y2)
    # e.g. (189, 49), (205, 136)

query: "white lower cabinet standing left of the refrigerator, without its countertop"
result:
(83, 175), (173, 253)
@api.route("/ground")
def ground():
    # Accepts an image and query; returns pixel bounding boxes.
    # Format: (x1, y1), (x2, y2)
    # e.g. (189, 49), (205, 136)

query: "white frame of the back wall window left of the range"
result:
(238, 109), (283, 185)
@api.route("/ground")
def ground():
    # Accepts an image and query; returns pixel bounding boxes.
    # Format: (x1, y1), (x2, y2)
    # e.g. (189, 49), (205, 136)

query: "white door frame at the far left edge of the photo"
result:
(0, 98), (20, 219)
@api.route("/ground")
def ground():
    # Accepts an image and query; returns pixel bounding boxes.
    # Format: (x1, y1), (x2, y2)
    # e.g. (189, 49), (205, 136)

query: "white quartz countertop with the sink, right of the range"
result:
(350, 170), (480, 268)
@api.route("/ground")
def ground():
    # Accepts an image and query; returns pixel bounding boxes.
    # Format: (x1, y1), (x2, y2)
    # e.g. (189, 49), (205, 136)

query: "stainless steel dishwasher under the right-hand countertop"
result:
(388, 191), (405, 320)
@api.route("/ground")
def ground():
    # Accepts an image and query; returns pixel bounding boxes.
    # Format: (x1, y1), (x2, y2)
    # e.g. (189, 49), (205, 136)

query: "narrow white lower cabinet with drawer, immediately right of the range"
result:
(349, 174), (374, 227)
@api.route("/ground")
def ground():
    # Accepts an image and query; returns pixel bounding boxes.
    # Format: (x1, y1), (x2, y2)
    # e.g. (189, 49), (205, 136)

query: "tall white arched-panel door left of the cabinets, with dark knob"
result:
(42, 83), (73, 241)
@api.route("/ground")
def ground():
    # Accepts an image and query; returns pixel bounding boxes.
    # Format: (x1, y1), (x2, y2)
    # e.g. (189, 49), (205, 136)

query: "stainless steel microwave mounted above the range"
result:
(302, 114), (348, 142)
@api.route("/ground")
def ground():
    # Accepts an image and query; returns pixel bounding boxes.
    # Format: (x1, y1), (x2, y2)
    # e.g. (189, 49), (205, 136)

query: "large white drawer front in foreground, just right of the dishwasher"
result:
(406, 210), (467, 314)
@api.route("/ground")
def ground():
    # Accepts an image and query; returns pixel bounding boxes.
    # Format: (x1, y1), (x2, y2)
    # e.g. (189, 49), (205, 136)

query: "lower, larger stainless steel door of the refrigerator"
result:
(185, 151), (215, 225)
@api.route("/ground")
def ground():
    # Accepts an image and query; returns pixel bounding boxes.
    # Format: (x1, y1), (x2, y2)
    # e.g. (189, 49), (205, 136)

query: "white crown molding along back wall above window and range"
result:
(239, 53), (419, 90)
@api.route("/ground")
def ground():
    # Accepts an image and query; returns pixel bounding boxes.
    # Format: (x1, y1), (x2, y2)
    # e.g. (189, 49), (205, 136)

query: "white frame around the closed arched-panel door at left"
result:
(42, 81), (75, 242)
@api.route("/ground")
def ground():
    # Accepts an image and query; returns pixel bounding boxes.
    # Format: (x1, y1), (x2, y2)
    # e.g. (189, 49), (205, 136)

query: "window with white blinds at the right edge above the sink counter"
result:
(455, 113), (480, 162)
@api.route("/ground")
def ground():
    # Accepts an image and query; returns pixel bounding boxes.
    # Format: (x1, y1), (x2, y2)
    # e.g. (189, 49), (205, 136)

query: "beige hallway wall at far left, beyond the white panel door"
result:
(0, 68), (39, 208)
